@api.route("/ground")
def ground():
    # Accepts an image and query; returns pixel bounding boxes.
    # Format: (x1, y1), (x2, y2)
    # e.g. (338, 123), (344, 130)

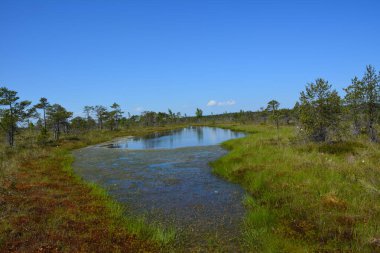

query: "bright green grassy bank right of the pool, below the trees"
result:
(212, 125), (380, 252)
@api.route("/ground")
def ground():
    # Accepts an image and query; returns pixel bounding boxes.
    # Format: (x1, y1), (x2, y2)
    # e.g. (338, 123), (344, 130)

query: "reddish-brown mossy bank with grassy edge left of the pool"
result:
(0, 126), (185, 252)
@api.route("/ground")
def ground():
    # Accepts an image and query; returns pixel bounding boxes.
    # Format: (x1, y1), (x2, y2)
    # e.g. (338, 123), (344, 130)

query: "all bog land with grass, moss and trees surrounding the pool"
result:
(0, 66), (380, 252)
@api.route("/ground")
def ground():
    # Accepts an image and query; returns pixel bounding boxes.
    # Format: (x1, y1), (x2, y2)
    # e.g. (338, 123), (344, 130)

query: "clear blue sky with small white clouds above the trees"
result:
(0, 0), (380, 115)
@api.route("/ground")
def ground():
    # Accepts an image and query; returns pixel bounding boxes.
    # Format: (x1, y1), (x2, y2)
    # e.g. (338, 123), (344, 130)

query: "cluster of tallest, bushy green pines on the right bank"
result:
(294, 65), (380, 142)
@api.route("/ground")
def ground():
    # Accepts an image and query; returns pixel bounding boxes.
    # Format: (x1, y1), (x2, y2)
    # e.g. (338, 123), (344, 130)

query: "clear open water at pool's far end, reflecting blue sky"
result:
(104, 127), (244, 150)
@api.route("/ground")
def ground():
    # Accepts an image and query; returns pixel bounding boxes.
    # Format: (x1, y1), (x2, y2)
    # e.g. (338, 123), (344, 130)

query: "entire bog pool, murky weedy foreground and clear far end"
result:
(73, 127), (244, 250)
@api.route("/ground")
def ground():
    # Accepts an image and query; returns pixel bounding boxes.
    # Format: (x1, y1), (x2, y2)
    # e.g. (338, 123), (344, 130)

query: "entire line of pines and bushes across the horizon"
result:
(0, 65), (380, 146)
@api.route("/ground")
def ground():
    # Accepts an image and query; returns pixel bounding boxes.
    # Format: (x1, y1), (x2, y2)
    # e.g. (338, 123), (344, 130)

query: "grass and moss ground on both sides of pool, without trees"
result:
(0, 124), (380, 252)
